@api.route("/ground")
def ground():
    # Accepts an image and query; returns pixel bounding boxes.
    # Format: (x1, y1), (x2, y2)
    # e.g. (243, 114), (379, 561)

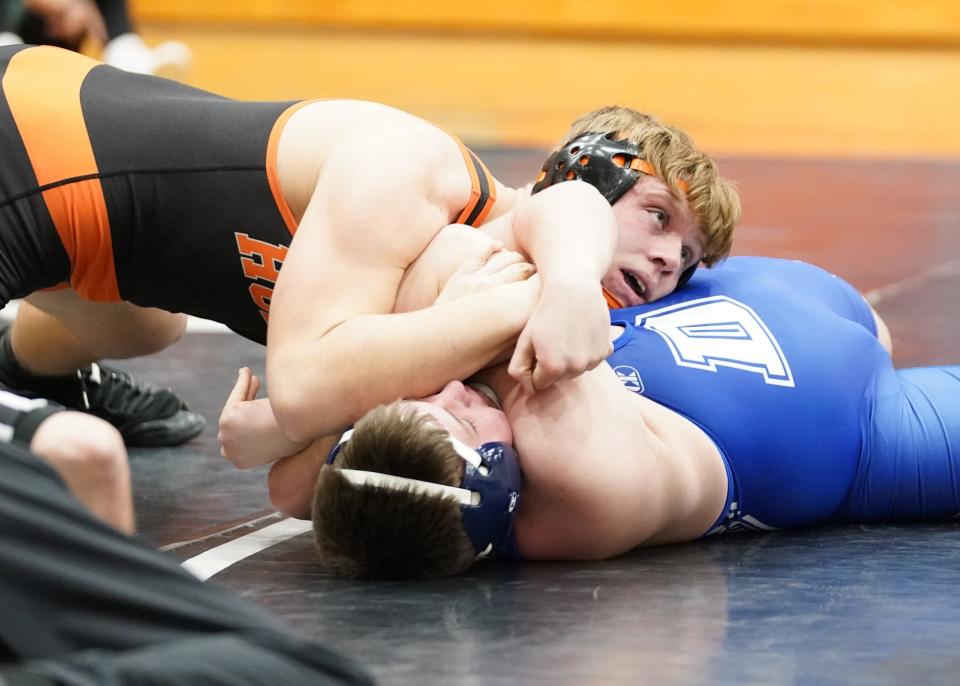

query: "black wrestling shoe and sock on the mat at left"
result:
(0, 328), (207, 446)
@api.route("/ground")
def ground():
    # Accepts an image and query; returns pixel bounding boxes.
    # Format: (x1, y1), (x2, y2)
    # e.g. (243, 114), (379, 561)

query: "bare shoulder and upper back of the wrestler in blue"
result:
(500, 364), (727, 559)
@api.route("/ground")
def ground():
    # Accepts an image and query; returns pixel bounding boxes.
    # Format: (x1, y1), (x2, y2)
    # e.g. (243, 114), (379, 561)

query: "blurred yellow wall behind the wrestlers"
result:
(131, 0), (960, 158)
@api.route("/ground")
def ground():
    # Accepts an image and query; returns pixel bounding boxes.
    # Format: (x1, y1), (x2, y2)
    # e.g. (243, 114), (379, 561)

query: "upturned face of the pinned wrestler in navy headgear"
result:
(408, 381), (513, 448)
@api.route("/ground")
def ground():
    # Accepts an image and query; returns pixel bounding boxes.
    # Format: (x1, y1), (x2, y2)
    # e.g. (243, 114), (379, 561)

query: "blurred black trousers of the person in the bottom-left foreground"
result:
(0, 444), (372, 686)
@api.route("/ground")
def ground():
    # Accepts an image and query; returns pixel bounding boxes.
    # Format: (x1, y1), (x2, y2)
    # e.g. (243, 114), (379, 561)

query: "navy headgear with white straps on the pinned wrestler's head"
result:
(327, 429), (522, 557)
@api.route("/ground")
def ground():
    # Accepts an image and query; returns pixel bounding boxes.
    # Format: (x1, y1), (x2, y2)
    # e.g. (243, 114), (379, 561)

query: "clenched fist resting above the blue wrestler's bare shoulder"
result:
(507, 282), (613, 393)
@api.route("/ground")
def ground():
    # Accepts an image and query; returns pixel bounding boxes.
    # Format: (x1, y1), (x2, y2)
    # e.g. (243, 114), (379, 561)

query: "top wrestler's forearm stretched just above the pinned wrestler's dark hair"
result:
(267, 279), (539, 441)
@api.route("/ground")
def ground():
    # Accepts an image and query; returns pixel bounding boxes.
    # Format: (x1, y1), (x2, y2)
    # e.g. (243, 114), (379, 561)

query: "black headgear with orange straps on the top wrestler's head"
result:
(531, 132), (697, 297)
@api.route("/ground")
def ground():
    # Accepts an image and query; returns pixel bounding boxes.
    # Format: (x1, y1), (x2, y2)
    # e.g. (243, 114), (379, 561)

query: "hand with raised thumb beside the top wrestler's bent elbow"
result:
(217, 367), (305, 469)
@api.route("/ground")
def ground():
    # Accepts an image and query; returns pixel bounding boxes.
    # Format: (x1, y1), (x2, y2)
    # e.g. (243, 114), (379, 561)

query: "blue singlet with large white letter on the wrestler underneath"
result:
(609, 257), (960, 533)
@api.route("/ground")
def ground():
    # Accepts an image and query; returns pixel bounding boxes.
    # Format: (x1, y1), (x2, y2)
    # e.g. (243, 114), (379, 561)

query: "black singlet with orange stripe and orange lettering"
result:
(0, 46), (493, 343)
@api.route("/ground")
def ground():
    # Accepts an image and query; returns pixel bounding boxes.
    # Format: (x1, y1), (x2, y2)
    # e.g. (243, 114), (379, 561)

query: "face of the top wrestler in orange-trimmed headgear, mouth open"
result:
(603, 174), (703, 307)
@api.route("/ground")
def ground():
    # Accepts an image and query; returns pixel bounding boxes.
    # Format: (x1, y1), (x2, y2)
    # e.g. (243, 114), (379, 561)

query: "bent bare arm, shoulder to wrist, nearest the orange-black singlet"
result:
(267, 122), (523, 441)
